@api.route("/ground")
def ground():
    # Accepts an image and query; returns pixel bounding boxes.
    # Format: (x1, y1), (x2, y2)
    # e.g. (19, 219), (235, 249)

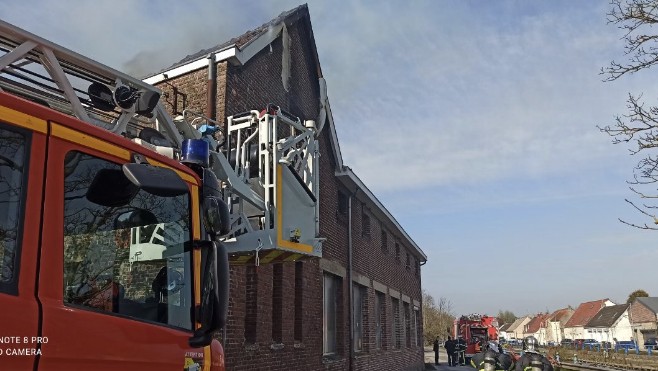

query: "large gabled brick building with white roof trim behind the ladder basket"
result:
(145, 5), (427, 370)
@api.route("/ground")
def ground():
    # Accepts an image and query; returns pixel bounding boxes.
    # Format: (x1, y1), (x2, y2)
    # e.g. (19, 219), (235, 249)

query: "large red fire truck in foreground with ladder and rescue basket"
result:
(0, 21), (322, 371)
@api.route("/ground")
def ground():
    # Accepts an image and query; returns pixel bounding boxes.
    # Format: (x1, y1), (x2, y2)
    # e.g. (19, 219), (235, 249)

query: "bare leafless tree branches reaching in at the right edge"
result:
(599, 0), (658, 229)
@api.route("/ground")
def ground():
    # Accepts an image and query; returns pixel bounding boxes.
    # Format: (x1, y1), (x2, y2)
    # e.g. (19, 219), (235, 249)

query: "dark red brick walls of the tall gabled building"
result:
(151, 7), (424, 370)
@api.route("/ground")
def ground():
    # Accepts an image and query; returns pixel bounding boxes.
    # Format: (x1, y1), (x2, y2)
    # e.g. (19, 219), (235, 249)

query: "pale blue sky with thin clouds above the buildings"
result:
(5, 0), (658, 315)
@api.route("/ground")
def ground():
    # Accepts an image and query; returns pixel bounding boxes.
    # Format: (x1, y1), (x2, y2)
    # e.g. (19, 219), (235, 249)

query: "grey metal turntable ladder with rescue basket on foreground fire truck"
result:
(0, 21), (322, 264)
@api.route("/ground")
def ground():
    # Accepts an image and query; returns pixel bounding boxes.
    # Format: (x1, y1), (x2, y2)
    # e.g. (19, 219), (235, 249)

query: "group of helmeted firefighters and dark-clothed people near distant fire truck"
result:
(434, 336), (553, 371)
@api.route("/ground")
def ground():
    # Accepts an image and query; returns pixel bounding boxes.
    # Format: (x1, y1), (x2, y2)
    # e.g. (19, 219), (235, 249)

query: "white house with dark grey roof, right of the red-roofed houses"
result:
(585, 304), (633, 343)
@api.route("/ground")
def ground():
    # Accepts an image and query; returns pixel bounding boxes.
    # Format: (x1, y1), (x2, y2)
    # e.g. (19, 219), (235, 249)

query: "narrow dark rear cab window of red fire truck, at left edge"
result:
(0, 126), (29, 294)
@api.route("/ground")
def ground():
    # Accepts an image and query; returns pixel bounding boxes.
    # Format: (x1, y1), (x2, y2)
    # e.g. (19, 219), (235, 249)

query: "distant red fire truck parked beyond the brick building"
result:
(453, 314), (498, 359)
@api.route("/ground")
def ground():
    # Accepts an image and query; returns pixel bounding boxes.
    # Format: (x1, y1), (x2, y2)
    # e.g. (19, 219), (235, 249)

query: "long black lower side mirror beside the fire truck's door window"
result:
(189, 241), (229, 348)
